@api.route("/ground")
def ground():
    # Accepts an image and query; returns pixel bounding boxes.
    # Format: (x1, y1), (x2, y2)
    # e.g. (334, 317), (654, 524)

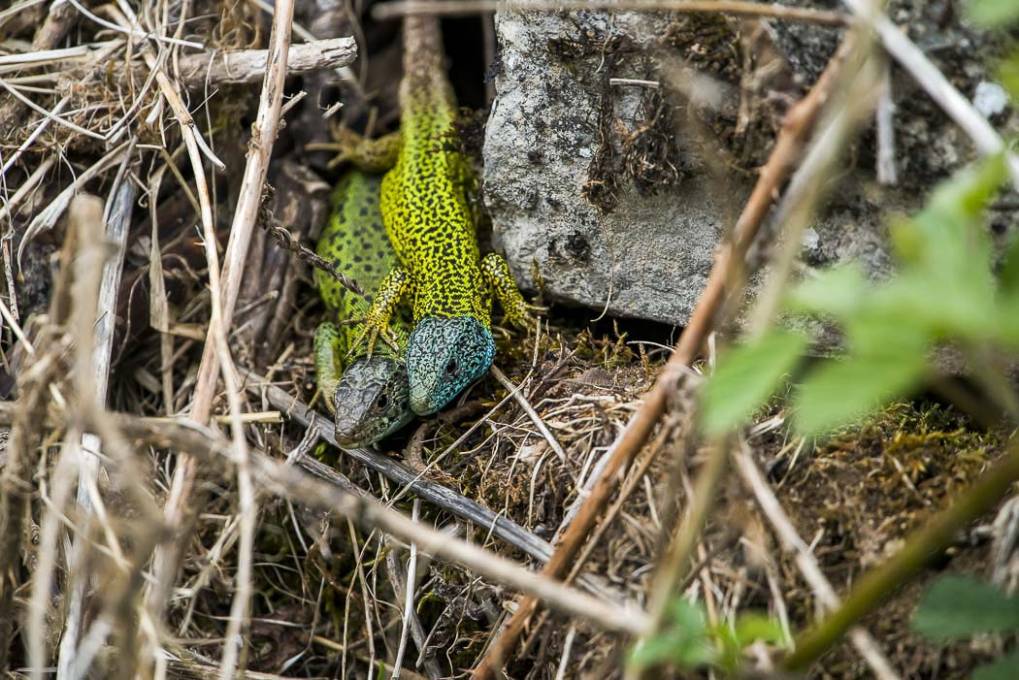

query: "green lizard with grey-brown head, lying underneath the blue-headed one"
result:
(314, 170), (414, 447)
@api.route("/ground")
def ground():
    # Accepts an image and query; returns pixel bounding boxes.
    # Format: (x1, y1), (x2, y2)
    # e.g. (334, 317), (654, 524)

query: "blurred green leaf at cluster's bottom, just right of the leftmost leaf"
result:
(793, 350), (926, 436)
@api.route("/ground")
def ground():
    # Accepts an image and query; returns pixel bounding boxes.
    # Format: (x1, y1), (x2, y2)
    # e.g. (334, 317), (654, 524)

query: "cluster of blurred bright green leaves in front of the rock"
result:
(702, 156), (1019, 435)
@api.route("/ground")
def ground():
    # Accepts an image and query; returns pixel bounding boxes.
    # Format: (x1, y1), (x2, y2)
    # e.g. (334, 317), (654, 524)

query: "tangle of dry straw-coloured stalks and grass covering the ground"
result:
(0, 0), (1019, 678)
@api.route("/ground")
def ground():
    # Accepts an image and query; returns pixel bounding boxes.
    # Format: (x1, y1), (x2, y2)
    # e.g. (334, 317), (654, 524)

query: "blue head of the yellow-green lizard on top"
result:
(407, 316), (495, 416)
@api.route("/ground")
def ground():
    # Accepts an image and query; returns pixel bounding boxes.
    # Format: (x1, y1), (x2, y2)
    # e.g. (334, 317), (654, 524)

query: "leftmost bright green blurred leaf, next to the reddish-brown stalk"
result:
(701, 328), (807, 436)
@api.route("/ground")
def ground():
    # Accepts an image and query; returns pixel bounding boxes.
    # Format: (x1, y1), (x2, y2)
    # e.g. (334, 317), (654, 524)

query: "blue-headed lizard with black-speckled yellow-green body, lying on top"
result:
(341, 16), (529, 415)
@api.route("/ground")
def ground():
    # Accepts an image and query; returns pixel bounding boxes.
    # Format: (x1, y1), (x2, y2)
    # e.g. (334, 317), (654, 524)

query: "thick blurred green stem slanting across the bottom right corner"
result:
(782, 442), (1019, 672)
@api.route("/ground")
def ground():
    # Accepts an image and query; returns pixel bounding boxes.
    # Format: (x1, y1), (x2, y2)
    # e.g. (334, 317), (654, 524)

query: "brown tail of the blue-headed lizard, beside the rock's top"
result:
(400, 14), (453, 108)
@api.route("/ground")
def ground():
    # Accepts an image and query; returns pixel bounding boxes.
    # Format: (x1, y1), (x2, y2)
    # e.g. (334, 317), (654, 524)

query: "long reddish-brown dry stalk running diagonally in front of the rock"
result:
(474, 36), (852, 680)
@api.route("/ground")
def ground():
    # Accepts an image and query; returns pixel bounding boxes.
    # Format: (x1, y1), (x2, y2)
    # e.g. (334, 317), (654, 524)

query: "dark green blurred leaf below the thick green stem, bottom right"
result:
(913, 575), (1019, 640)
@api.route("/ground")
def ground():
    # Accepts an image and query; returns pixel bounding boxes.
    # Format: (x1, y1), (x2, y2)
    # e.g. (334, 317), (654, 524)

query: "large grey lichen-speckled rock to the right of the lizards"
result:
(484, 0), (1011, 324)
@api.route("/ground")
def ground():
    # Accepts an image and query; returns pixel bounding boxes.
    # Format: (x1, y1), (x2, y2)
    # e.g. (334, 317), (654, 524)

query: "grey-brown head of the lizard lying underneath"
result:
(333, 356), (414, 447)
